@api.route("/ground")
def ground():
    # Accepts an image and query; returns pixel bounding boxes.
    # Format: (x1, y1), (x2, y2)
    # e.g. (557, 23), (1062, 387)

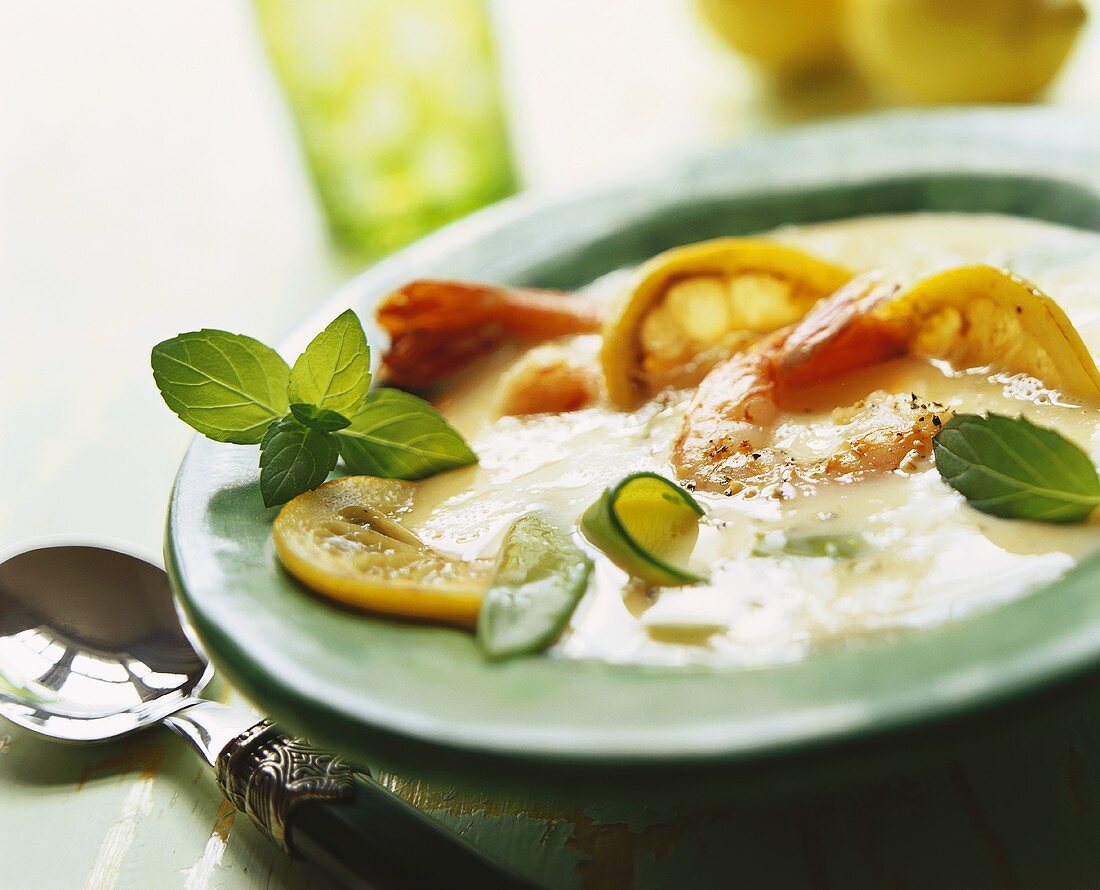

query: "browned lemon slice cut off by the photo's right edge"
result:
(881, 266), (1100, 404)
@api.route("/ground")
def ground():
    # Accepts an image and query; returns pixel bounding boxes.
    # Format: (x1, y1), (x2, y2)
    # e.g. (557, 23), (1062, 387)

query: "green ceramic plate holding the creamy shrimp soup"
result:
(167, 103), (1100, 765)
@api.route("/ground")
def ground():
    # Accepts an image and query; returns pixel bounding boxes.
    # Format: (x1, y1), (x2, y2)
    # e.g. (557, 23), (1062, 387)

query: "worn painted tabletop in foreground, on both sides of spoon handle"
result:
(10, 674), (1100, 890)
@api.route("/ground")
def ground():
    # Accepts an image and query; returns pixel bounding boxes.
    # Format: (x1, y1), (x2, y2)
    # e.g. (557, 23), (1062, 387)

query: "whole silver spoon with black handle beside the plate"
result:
(0, 543), (530, 887)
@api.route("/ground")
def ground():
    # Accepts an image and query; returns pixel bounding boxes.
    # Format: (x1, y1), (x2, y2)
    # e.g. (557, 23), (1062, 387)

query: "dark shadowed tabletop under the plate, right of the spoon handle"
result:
(397, 672), (1100, 890)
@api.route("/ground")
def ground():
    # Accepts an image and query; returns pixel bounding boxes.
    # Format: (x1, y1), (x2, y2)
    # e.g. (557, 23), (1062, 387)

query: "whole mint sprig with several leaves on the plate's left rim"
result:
(151, 309), (477, 507)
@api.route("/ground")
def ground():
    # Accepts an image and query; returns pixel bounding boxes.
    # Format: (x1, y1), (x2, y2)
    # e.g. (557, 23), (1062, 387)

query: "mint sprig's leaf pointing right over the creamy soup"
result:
(334, 389), (477, 480)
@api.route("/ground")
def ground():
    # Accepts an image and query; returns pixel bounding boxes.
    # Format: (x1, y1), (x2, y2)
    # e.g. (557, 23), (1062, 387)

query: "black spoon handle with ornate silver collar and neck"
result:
(165, 702), (534, 889)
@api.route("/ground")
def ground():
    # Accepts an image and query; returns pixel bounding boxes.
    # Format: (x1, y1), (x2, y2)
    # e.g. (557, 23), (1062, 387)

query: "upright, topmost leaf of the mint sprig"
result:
(287, 309), (371, 417)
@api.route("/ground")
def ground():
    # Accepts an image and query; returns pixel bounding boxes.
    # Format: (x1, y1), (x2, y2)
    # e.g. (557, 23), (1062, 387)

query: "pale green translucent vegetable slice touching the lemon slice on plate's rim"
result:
(477, 514), (592, 659)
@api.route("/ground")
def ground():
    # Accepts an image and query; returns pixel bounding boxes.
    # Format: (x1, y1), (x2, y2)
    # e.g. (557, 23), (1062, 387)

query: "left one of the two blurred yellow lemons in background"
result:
(695, 0), (843, 74)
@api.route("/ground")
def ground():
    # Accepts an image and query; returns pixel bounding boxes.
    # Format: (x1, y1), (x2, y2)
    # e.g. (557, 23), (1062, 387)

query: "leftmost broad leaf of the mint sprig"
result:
(150, 329), (290, 444)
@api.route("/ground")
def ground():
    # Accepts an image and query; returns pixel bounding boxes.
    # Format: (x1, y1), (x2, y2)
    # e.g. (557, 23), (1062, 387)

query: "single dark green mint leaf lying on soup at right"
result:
(933, 414), (1100, 523)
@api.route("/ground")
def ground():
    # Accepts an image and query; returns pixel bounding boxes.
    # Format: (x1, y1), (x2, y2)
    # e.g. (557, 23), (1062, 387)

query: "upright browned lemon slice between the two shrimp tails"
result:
(600, 238), (851, 408)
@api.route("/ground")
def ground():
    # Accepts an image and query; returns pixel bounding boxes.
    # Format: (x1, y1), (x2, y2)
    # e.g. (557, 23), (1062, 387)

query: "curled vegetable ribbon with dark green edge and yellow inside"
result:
(581, 473), (705, 586)
